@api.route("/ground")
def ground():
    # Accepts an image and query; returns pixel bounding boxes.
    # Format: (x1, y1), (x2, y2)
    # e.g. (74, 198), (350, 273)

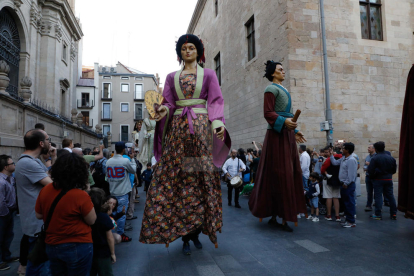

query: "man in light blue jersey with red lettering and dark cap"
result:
(106, 142), (137, 242)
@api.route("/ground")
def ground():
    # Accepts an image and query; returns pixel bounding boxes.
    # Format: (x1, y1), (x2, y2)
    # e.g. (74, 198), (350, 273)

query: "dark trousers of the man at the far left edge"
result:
(0, 211), (14, 262)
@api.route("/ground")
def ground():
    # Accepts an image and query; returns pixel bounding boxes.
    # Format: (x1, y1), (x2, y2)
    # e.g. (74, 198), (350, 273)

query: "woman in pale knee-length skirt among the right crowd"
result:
(321, 147), (342, 222)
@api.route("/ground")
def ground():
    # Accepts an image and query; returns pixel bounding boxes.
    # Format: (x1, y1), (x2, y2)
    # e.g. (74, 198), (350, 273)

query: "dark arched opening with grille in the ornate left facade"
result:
(0, 9), (20, 97)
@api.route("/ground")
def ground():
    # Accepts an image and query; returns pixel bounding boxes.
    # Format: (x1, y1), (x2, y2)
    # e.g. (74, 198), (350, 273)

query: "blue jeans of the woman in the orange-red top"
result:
(46, 243), (93, 276)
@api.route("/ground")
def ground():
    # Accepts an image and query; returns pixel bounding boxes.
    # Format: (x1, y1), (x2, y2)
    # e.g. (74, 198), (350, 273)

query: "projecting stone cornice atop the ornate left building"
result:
(39, 0), (83, 41)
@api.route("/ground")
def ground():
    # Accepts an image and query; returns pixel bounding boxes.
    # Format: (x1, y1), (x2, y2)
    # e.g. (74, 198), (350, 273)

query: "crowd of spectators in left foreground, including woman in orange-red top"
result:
(0, 124), (152, 275)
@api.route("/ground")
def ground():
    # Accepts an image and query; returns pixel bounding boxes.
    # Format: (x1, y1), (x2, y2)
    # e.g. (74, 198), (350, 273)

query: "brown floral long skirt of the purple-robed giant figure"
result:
(139, 114), (223, 244)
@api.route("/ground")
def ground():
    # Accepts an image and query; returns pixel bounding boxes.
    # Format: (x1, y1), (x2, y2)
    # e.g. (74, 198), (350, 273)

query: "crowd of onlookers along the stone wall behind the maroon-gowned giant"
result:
(222, 141), (397, 228)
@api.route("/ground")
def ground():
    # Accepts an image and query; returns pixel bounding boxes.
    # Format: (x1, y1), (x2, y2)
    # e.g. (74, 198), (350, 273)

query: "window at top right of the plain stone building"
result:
(359, 0), (383, 40)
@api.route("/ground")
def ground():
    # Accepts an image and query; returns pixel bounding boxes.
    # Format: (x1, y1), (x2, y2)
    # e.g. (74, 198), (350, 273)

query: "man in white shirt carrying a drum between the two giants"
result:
(223, 149), (246, 208)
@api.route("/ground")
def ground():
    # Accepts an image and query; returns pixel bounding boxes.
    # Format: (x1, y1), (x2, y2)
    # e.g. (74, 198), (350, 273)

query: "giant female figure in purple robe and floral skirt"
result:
(140, 34), (231, 255)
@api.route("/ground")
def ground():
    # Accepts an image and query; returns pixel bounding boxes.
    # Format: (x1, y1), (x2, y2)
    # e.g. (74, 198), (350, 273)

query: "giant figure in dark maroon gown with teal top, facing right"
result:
(249, 60), (306, 232)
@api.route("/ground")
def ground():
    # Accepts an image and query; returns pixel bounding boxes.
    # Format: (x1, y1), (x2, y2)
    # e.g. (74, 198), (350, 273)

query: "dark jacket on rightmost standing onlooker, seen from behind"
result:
(368, 152), (397, 179)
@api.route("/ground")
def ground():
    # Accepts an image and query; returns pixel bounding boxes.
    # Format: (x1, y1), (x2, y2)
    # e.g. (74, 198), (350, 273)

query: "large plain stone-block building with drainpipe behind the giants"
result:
(188, 0), (414, 180)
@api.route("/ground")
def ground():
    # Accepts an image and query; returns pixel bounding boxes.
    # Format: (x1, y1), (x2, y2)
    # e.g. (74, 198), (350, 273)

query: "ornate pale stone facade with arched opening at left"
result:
(0, 0), (99, 158)
